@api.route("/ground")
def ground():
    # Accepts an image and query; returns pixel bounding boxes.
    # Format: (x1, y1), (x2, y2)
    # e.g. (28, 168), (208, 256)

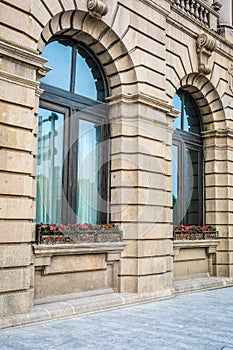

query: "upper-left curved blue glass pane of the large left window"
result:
(41, 41), (72, 91)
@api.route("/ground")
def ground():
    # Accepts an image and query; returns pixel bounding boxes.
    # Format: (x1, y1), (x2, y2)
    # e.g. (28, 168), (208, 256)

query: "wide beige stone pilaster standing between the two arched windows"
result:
(109, 93), (176, 296)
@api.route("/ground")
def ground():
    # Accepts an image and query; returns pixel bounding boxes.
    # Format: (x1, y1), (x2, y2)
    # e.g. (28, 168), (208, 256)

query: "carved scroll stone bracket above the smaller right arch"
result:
(197, 33), (216, 74)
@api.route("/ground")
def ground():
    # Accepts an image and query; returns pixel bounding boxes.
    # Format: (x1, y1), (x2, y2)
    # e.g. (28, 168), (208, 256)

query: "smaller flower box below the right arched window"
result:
(173, 225), (218, 240)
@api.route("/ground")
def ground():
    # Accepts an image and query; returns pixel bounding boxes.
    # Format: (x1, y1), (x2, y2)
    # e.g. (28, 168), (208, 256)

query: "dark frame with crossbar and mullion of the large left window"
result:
(39, 38), (110, 224)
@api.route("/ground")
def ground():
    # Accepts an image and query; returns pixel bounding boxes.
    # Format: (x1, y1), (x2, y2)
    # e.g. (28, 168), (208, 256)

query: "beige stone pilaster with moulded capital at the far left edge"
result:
(0, 40), (46, 317)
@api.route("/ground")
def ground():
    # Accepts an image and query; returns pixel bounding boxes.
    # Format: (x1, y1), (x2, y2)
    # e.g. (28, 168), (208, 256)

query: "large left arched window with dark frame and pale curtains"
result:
(36, 38), (108, 224)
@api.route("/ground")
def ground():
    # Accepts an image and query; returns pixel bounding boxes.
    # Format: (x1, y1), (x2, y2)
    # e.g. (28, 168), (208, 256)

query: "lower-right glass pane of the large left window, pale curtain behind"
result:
(77, 119), (101, 224)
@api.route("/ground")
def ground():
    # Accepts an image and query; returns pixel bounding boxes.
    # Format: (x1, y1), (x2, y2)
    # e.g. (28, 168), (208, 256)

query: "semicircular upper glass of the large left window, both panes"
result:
(41, 38), (106, 101)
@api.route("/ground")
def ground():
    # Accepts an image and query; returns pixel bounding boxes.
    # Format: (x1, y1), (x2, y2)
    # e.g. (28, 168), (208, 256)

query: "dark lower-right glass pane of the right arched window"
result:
(185, 149), (199, 225)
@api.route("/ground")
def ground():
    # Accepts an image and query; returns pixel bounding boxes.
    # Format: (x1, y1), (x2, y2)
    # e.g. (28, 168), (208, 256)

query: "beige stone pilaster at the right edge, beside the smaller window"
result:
(203, 129), (233, 277)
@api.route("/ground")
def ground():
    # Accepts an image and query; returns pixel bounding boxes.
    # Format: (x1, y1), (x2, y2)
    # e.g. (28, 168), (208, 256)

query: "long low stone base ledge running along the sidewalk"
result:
(0, 275), (233, 329)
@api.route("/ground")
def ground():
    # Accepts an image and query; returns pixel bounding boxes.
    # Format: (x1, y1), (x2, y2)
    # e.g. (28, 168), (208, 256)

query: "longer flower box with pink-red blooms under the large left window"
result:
(37, 224), (123, 244)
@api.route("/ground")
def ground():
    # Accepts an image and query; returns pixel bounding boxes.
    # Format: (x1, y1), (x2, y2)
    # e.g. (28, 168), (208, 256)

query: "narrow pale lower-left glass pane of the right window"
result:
(172, 145), (179, 225)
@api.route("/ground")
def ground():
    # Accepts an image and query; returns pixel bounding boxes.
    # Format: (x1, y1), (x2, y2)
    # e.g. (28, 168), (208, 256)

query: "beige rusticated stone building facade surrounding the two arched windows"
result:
(0, 0), (233, 317)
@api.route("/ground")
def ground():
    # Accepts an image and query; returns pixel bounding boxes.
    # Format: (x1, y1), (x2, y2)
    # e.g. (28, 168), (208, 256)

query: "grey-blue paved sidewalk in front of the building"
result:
(0, 287), (233, 350)
